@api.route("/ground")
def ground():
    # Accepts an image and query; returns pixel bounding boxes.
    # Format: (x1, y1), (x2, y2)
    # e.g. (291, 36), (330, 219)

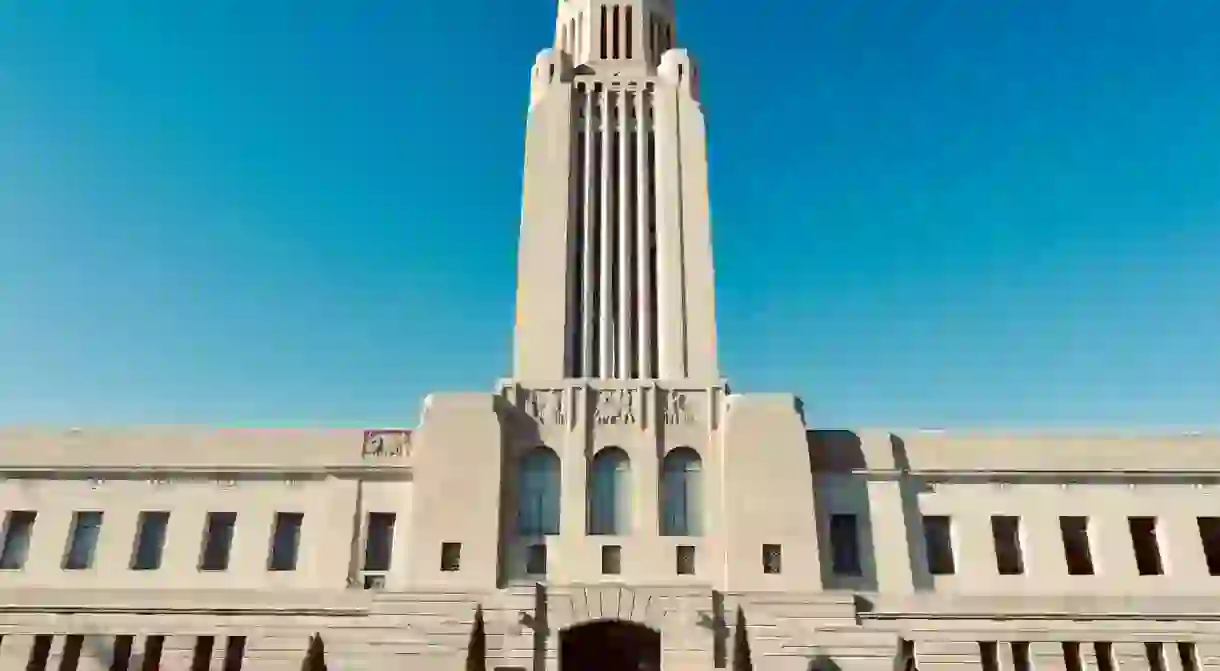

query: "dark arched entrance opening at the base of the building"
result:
(559, 620), (661, 671)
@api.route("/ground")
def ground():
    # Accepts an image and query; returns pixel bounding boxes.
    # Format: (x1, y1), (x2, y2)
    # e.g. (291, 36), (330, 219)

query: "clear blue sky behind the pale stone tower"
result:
(0, 0), (1220, 427)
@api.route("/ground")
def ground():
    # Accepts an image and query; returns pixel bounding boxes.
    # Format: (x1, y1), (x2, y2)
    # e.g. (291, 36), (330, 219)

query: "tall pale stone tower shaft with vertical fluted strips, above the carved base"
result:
(514, 0), (720, 384)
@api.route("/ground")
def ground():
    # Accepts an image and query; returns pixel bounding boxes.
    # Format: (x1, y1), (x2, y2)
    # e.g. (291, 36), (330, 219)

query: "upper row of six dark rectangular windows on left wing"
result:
(0, 510), (395, 571)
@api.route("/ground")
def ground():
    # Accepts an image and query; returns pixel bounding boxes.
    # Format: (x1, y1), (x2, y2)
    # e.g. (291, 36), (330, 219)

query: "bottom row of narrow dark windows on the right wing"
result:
(903, 641), (1199, 671)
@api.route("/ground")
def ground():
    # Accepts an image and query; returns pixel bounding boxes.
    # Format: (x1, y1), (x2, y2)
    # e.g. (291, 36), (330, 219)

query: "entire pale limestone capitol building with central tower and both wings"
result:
(0, 0), (1220, 671)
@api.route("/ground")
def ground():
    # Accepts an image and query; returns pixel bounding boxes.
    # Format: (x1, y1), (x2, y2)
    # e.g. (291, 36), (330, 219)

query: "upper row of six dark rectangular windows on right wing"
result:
(830, 514), (1220, 576)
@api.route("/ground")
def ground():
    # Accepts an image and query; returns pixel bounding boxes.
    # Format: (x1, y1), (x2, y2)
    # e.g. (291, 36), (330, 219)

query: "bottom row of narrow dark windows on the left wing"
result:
(0, 633), (245, 671)
